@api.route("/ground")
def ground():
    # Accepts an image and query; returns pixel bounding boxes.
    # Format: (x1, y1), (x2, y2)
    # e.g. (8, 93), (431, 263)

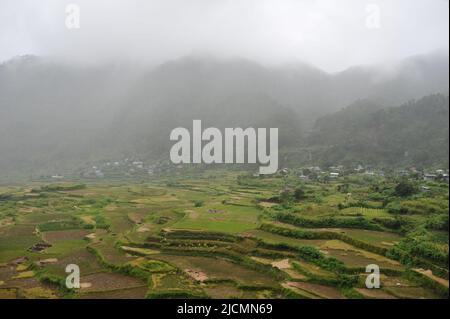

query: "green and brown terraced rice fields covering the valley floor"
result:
(0, 169), (448, 299)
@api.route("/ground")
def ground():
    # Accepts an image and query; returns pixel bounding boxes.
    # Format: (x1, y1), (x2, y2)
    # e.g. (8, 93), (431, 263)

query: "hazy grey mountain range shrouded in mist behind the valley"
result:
(0, 53), (449, 176)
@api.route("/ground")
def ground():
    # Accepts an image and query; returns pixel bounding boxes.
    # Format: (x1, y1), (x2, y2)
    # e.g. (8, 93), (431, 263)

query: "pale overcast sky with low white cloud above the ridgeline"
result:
(0, 0), (449, 71)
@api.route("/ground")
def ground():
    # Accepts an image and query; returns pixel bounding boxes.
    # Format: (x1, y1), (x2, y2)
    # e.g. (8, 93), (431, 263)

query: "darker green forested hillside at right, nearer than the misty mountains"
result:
(308, 94), (449, 166)
